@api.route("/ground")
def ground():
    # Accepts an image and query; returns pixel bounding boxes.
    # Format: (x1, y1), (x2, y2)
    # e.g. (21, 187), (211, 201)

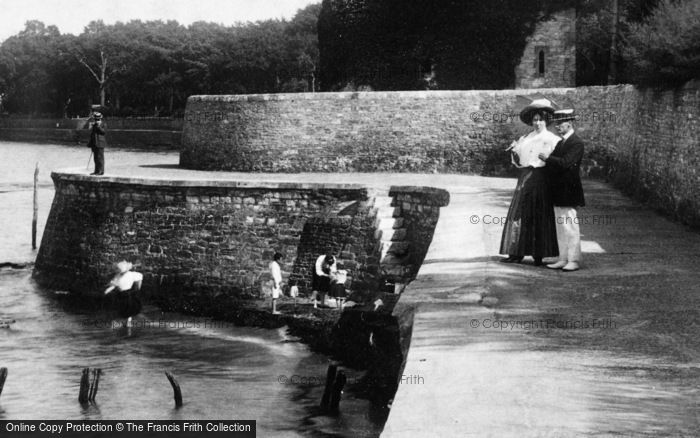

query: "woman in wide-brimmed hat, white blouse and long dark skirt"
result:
(500, 99), (559, 266)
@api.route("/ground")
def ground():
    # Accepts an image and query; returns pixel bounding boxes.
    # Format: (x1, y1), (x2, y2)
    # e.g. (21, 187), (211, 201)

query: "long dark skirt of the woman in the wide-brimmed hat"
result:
(500, 167), (559, 258)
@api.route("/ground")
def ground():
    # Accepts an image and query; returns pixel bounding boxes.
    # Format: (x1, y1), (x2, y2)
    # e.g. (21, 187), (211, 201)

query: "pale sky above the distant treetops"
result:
(0, 0), (321, 42)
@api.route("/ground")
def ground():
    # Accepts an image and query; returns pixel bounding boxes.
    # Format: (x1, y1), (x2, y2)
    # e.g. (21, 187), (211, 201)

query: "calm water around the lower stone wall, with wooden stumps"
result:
(0, 142), (381, 436)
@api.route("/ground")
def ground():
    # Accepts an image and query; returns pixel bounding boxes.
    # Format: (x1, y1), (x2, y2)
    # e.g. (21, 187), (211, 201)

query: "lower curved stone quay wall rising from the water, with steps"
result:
(35, 173), (449, 311)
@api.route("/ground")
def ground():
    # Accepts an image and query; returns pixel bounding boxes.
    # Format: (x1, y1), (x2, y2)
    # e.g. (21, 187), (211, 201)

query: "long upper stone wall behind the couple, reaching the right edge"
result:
(180, 83), (700, 226)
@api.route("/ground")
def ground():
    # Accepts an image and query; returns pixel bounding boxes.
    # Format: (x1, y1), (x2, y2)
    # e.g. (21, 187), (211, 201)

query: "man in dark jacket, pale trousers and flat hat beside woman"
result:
(539, 109), (586, 271)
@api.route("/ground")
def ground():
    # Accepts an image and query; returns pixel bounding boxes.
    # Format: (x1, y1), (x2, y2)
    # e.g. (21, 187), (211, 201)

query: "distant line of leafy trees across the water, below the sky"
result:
(0, 4), (320, 116)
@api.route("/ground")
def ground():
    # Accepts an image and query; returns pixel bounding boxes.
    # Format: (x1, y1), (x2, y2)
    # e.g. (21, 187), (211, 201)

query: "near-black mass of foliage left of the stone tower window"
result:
(318, 0), (574, 90)
